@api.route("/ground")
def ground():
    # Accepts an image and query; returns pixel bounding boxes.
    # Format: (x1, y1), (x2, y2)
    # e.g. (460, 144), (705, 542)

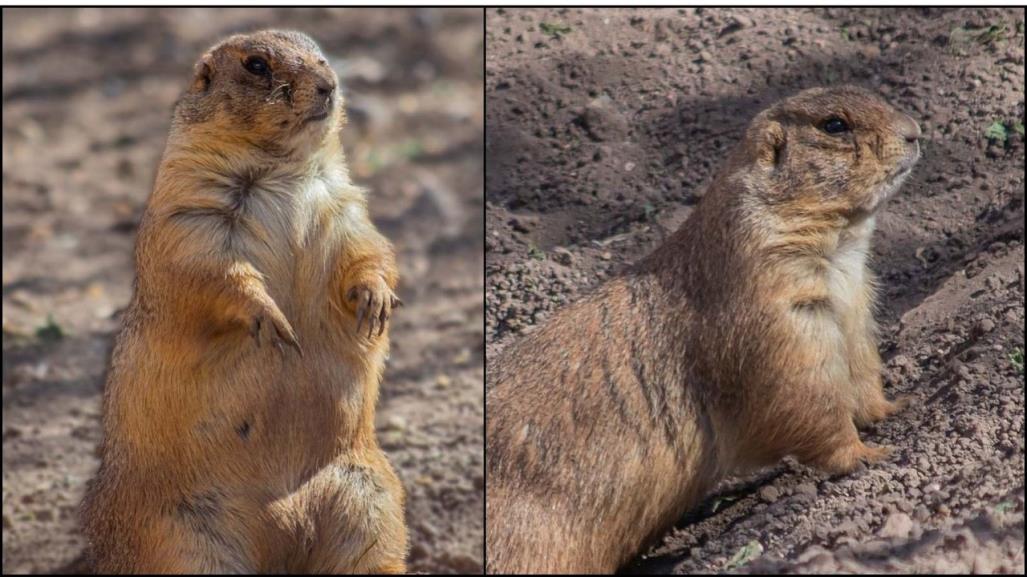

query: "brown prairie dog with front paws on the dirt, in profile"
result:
(486, 86), (920, 573)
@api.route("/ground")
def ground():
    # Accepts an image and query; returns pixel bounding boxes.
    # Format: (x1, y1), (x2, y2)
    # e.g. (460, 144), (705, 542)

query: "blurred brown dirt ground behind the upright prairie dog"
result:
(3, 8), (485, 573)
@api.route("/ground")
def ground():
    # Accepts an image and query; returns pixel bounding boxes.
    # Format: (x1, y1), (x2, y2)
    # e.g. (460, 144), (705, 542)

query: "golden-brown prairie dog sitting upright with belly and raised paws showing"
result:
(83, 31), (408, 573)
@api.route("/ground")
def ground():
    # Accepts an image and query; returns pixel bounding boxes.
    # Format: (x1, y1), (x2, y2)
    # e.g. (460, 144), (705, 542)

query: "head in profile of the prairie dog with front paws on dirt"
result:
(746, 86), (920, 218)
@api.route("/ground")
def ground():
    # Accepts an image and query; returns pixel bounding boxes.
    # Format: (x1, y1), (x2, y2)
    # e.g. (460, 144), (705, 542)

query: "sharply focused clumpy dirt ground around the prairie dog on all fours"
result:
(486, 8), (1024, 574)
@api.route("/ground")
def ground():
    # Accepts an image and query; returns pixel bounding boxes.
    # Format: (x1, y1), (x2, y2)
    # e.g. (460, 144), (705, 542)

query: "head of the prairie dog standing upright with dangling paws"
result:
(175, 30), (345, 156)
